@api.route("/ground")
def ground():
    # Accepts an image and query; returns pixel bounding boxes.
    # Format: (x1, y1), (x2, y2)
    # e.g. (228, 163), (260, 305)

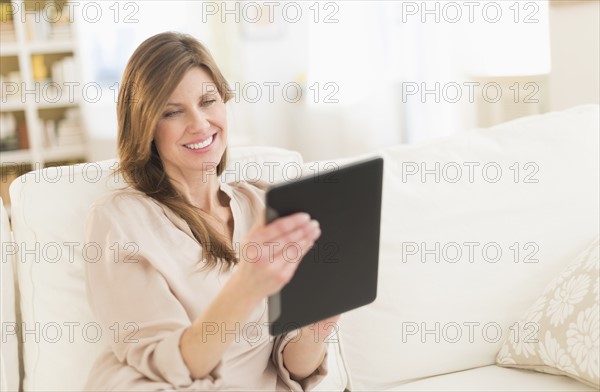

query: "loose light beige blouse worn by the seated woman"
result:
(86, 182), (327, 391)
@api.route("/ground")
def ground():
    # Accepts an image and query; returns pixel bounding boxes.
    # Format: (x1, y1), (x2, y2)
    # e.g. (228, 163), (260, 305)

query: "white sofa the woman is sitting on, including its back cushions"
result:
(2, 105), (599, 391)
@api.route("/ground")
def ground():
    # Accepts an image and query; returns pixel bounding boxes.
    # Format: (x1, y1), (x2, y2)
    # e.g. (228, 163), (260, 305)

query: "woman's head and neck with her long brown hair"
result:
(117, 33), (233, 265)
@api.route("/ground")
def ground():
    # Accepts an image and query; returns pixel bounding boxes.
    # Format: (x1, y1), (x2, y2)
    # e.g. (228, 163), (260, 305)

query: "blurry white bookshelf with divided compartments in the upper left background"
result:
(0, 0), (89, 171)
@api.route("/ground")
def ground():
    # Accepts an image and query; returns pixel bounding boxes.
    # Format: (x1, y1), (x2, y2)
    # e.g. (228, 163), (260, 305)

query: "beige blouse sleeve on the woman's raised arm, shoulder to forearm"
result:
(85, 196), (222, 390)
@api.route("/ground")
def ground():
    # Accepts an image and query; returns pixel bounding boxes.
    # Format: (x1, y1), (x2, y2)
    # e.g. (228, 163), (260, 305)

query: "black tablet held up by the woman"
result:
(266, 157), (383, 336)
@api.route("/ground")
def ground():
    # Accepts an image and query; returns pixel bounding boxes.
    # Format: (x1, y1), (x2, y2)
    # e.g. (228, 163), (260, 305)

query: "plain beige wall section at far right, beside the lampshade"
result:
(550, 0), (600, 110)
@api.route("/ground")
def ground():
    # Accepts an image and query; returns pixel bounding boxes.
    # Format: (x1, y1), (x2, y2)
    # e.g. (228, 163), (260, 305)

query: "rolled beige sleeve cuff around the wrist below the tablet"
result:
(271, 329), (329, 391)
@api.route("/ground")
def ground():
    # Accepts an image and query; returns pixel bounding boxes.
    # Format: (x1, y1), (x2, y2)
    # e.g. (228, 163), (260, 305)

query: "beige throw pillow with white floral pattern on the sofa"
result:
(496, 234), (600, 388)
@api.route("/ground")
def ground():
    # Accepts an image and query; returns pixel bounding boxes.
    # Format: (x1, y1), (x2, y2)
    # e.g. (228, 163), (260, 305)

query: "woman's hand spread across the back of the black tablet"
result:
(236, 208), (321, 298)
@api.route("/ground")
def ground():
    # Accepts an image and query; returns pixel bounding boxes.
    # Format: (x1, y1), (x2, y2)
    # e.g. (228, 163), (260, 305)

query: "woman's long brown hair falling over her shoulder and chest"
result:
(117, 32), (237, 268)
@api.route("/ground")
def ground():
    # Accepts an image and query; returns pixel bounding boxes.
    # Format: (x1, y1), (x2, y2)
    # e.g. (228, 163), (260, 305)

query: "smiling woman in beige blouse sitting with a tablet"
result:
(86, 33), (337, 391)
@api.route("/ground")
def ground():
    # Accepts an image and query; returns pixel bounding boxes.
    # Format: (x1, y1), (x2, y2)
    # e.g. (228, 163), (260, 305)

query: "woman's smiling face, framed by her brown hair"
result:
(154, 67), (227, 178)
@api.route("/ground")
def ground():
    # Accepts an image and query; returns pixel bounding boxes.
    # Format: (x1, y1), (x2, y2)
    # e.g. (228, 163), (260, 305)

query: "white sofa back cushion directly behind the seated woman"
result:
(10, 147), (347, 391)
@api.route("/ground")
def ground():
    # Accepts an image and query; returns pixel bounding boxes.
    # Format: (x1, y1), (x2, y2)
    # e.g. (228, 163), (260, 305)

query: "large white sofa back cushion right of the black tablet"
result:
(340, 105), (600, 390)
